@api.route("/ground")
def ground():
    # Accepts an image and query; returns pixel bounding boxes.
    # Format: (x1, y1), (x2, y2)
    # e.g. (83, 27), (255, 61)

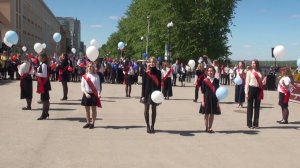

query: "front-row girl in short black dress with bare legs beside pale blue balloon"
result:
(199, 66), (221, 133)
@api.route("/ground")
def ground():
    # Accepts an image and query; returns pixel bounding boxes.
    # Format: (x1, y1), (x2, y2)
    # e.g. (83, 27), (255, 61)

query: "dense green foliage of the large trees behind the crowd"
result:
(100, 0), (239, 61)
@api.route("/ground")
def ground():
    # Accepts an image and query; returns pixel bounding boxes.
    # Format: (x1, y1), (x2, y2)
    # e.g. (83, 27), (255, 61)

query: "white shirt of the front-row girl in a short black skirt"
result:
(81, 73), (100, 94)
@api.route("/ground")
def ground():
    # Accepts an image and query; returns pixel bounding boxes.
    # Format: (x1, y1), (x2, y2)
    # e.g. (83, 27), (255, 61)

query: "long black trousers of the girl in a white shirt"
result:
(247, 86), (261, 127)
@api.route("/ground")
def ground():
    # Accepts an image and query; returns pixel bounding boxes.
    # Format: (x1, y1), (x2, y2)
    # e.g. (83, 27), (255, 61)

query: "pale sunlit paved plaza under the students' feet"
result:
(0, 80), (300, 168)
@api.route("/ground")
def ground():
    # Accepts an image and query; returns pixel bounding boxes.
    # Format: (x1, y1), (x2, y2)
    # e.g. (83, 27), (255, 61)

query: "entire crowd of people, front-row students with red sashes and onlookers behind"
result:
(0, 52), (293, 133)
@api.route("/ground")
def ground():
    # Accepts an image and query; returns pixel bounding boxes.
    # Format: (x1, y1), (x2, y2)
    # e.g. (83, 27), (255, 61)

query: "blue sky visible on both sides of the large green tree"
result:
(44, 0), (300, 60)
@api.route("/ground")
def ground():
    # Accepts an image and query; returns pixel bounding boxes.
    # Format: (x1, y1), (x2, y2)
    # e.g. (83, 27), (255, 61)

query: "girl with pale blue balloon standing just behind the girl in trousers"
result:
(234, 61), (246, 108)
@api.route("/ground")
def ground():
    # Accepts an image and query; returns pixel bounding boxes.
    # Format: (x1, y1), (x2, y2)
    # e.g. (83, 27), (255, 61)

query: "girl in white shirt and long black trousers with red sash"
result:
(245, 59), (264, 129)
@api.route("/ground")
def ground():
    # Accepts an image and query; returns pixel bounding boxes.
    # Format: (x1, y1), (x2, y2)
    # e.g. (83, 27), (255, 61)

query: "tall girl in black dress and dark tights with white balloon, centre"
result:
(141, 56), (161, 134)
